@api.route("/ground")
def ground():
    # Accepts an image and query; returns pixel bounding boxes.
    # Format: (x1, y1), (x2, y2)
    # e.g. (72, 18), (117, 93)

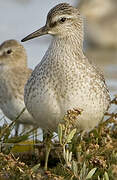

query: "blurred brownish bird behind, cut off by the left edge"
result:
(0, 40), (34, 134)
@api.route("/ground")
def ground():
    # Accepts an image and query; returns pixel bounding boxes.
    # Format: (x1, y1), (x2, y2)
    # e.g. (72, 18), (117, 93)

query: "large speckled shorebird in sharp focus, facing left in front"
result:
(22, 3), (110, 169)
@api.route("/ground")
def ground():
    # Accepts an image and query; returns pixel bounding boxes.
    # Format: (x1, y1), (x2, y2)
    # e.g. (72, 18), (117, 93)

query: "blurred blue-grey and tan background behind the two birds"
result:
(0, 0), (117, 133)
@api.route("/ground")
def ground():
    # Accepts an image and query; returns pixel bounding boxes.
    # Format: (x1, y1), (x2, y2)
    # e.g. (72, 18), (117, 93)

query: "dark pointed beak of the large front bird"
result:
(21, 25), (48, 42)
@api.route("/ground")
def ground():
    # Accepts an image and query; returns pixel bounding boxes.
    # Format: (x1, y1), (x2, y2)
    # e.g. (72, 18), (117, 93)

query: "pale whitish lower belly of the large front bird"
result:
(27, 86), (104, 131)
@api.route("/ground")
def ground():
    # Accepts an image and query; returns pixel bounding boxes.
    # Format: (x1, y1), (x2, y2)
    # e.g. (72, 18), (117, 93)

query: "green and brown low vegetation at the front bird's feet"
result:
(0, 97), (117, 180)
